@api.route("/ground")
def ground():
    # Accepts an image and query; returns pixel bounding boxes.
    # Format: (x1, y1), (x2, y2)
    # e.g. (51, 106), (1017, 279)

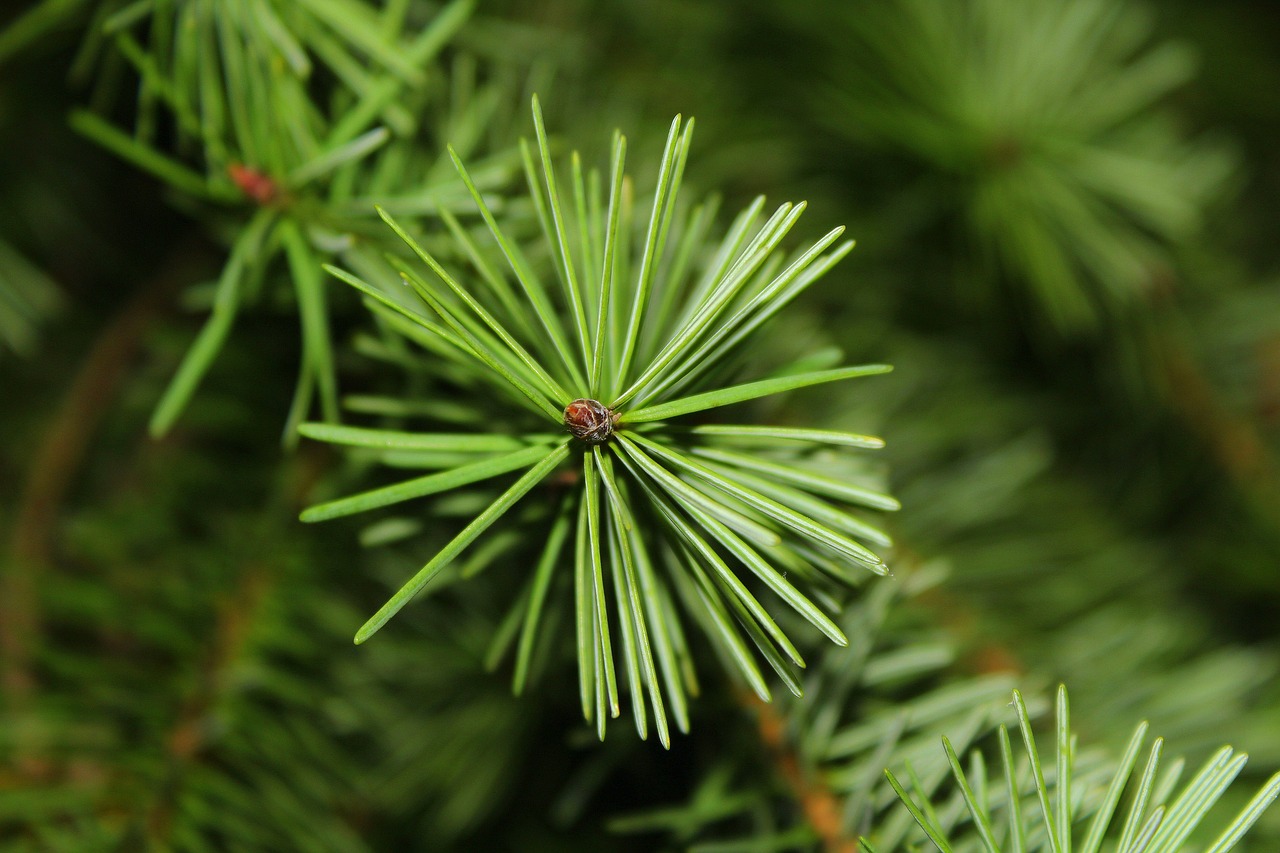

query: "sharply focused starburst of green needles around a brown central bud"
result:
(302, 97), (897, 744)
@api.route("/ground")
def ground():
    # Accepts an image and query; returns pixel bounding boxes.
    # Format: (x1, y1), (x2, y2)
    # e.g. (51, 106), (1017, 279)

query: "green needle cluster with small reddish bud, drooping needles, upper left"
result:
(49, 0), (535, 438)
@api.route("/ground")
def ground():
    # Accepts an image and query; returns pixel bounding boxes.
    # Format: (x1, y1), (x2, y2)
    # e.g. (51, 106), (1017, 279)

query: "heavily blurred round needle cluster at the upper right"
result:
(817, 0), (1234, 333)
